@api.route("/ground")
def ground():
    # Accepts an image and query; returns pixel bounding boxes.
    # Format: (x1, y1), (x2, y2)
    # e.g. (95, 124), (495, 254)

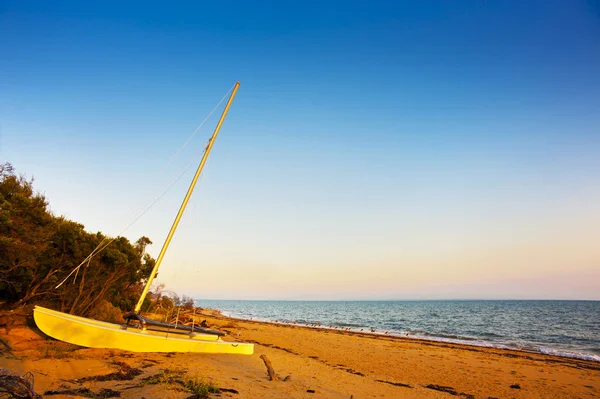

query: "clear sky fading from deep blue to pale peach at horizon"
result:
(0, 0), (600, 299)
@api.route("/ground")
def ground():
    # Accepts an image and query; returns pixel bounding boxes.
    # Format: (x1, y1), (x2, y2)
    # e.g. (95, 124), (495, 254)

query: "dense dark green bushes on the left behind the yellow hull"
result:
(0, 163), (155, 317)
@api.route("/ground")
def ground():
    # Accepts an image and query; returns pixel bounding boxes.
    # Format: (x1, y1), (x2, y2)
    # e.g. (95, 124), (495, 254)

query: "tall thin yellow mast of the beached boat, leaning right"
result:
(134, 82), (240, 313)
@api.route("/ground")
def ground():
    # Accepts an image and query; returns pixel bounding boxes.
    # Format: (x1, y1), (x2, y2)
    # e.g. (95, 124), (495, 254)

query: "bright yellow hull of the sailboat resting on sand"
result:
(33, 306), (254, 355)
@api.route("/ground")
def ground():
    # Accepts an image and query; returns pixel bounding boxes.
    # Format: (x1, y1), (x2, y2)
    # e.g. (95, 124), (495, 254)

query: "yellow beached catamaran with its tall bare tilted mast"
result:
(33, 82), (254, 355)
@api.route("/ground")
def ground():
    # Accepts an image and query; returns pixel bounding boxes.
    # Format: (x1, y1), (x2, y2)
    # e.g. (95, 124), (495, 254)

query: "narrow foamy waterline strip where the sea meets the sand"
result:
(209, 308), (600, 363)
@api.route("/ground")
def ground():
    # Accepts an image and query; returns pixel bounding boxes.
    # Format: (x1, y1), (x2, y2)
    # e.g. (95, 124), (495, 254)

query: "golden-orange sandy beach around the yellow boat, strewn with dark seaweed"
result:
(0, 310), (600, 399)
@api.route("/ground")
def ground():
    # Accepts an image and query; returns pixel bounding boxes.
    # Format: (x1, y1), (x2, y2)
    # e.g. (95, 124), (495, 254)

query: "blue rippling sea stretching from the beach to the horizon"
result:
(196, 300), (600, 362)
